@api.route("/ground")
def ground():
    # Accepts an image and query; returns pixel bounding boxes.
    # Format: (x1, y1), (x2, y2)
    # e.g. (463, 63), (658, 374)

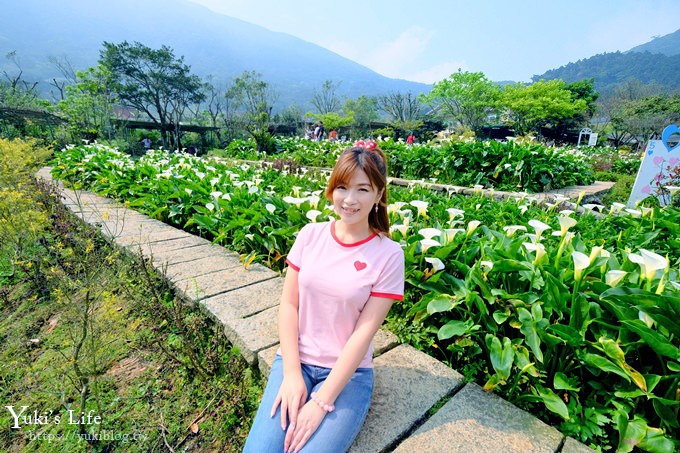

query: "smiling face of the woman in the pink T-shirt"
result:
(333, 169), (382, 226)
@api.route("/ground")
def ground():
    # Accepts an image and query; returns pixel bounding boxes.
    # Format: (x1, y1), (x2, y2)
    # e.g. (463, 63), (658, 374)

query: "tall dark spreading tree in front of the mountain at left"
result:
(99, 41), (205, 149)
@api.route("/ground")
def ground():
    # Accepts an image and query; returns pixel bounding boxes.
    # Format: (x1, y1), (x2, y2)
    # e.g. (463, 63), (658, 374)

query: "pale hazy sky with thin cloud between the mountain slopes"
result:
(191, 0), (680, 83)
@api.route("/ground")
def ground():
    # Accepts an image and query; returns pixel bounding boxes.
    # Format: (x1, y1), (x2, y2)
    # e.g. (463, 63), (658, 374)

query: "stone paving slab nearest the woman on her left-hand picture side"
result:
(224, 306), (279, 366)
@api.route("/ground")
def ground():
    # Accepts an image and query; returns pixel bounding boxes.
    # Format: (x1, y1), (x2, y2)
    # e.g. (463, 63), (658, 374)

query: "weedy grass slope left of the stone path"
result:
(0, 137), (262, 452)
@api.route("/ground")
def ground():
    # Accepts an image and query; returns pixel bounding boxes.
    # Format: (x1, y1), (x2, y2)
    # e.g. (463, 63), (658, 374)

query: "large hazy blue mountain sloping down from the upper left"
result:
(0, 0), (430, 109)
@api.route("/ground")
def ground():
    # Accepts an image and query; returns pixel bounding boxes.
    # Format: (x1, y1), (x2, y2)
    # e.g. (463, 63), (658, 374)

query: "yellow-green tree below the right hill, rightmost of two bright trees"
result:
(503, 79), (587, 134)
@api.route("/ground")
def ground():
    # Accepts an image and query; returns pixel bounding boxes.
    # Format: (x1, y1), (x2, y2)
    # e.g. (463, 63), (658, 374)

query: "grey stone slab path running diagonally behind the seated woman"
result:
(38, 168), (592, 453)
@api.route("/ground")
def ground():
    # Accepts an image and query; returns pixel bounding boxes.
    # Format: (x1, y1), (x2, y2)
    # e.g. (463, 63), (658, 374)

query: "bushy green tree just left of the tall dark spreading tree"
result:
(58, 66), (116, 140)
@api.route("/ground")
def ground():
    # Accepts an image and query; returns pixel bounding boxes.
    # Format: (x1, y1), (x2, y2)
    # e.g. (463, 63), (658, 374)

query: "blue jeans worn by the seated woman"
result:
(243, 355), (373, 453)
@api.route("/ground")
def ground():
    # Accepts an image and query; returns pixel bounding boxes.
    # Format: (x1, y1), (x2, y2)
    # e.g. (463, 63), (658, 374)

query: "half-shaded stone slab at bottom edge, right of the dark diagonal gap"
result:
(394, 384), (563, 453)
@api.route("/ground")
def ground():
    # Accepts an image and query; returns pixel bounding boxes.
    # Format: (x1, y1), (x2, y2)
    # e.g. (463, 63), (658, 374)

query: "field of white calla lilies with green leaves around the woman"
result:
(53, 139), (680, 452)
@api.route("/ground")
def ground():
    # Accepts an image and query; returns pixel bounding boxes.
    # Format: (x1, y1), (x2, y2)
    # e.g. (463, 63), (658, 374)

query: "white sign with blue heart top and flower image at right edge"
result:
(628, 124), (680, 208)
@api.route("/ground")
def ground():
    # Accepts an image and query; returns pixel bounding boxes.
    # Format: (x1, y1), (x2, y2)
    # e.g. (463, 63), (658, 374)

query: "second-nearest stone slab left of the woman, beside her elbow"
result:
(202, 276), (283, 322)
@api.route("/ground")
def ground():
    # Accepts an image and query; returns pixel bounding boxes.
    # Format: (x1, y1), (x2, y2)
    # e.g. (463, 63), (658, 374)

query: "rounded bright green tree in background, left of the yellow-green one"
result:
(421, 69), (501, 131)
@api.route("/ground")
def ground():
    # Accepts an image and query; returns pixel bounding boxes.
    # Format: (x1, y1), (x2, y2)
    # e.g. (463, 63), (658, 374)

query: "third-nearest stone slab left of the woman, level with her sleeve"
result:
(175, 264), (278, 300)
